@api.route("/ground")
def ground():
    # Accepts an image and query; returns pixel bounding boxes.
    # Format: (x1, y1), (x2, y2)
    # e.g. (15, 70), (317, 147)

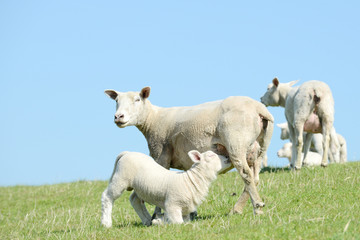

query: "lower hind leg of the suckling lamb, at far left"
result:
(101, 185), (125, 228)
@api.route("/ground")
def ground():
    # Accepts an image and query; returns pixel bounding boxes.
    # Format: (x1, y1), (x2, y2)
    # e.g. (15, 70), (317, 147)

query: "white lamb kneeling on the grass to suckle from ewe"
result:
(101, 150), (231, 227)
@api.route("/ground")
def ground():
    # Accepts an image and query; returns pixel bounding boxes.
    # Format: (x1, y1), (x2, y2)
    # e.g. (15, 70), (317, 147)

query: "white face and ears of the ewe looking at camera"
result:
(105, 87), (150, 128)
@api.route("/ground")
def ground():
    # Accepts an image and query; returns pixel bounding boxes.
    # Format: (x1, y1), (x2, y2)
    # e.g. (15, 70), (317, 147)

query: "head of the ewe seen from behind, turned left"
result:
(260, 78), (298, 107)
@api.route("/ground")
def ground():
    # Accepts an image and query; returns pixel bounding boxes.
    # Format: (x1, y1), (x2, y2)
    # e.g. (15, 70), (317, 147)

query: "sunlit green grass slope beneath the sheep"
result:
(0, 162), (360, 239)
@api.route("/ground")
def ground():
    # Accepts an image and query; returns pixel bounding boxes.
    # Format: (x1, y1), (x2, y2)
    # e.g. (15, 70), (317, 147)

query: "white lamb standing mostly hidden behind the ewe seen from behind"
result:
(277, 122), (347, 163)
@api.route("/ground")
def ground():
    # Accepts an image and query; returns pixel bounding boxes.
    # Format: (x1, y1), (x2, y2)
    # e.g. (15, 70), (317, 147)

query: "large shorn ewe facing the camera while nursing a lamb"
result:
(105, 87), (274, 214)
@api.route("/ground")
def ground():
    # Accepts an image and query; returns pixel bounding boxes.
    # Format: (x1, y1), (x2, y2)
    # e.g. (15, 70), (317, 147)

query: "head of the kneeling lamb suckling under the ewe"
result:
(188, 150), (232, 173)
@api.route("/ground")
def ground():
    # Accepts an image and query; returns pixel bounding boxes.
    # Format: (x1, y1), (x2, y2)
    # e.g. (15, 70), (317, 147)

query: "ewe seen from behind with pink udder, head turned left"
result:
(261, 78), (334, 169)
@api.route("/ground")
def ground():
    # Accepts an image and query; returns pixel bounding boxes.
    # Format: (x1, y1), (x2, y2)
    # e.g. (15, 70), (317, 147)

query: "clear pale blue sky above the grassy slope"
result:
(0, 0), (360, 186)
